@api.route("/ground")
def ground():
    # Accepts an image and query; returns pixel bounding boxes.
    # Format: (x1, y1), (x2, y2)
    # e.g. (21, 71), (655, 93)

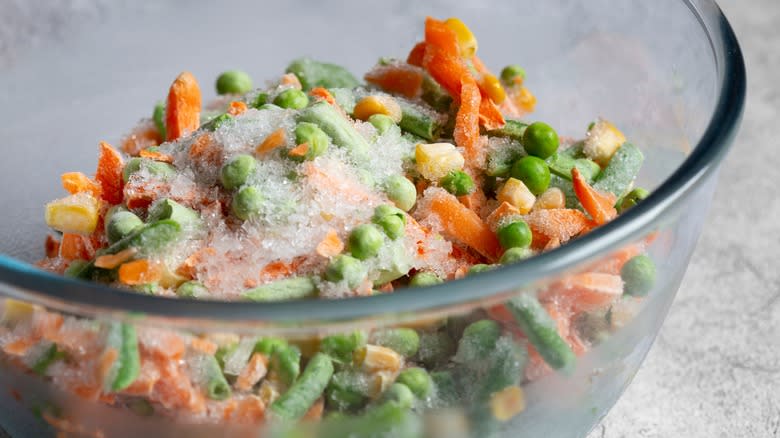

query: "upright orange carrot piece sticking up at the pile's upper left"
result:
(165, 71), (201, 141)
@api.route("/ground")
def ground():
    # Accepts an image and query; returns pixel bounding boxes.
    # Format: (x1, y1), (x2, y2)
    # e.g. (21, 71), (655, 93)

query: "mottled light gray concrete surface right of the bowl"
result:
(589, 0), (780, 438)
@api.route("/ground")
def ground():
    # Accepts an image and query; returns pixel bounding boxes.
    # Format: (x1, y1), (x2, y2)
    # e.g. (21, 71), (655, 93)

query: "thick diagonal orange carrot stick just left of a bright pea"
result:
(430, 191), (501, 261)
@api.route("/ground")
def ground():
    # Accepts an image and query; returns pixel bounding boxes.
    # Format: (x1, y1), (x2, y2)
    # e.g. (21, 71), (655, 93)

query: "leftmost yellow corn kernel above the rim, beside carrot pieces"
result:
(45, 193), (100, 234)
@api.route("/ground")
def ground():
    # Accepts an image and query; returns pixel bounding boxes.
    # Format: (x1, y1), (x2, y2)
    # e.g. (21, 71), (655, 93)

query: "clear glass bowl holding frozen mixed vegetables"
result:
(0, 0), (746, 437)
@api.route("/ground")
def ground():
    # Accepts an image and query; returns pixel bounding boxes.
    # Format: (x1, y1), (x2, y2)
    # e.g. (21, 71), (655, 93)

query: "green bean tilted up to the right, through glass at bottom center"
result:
(270, 353), (333, 421)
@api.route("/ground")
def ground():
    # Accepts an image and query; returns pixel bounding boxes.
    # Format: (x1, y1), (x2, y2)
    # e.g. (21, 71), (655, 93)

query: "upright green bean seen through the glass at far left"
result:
(105, 322), (141, 391)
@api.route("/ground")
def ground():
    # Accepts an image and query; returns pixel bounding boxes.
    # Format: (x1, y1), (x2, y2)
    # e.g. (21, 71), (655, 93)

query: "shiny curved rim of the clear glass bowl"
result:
(0, 0), (747, 325)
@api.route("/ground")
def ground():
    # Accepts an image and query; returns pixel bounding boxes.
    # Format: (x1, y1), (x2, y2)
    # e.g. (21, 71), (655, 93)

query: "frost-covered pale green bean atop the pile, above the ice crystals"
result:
(299, 102), (370, 164)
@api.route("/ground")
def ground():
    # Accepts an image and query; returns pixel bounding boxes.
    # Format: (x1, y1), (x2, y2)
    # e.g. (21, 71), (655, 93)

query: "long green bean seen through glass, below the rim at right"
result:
(507, 294), (576, 373)
